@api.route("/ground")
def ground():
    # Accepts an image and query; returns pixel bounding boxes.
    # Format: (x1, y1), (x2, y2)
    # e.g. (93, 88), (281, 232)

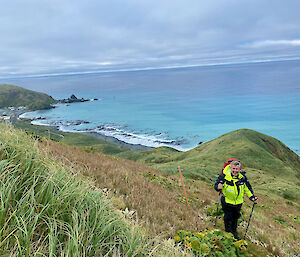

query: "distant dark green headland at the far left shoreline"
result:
(0, 84), (55, 110)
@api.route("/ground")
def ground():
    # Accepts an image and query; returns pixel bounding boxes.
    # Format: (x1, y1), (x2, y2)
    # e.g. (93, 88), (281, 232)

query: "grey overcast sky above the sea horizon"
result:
(0, 0), (300, 77)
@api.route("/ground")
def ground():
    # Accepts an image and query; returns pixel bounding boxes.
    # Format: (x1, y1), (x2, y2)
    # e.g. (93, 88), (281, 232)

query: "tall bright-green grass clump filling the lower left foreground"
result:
(0, 125), (173, 256)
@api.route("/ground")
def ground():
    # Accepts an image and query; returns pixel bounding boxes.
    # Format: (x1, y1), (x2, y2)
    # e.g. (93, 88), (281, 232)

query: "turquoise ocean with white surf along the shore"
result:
(0, 61), (300, 154)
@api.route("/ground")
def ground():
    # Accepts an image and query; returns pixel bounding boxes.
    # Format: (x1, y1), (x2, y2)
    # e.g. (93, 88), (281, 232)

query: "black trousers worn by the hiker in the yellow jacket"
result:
(221, 195), (242, 233)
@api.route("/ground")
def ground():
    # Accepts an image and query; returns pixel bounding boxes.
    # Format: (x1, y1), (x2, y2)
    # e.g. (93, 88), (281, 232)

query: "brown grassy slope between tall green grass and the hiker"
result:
(45, 134), (277, 254)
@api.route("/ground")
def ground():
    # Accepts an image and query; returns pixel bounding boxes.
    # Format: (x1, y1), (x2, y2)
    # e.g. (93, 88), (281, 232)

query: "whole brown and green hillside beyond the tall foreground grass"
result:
(11, 121), (300, 256)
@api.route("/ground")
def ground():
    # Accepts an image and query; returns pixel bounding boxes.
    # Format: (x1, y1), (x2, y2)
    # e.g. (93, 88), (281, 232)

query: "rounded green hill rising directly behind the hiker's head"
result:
(119, 129), (300, 180)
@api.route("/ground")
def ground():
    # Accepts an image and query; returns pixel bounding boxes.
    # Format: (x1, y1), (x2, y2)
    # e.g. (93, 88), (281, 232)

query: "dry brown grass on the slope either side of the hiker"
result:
(41, 139), (300, 256)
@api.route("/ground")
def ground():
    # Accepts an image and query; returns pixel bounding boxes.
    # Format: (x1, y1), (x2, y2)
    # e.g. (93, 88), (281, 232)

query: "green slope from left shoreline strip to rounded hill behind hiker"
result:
(14, 122), (300, 183)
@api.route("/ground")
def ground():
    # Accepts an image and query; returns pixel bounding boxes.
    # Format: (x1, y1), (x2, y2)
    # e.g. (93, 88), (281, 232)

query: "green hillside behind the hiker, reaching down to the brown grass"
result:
(118, 129), (300, 202)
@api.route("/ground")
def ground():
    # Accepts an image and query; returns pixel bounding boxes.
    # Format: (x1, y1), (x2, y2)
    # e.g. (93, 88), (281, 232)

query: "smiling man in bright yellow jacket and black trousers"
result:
(214, 161), (257, 240)
